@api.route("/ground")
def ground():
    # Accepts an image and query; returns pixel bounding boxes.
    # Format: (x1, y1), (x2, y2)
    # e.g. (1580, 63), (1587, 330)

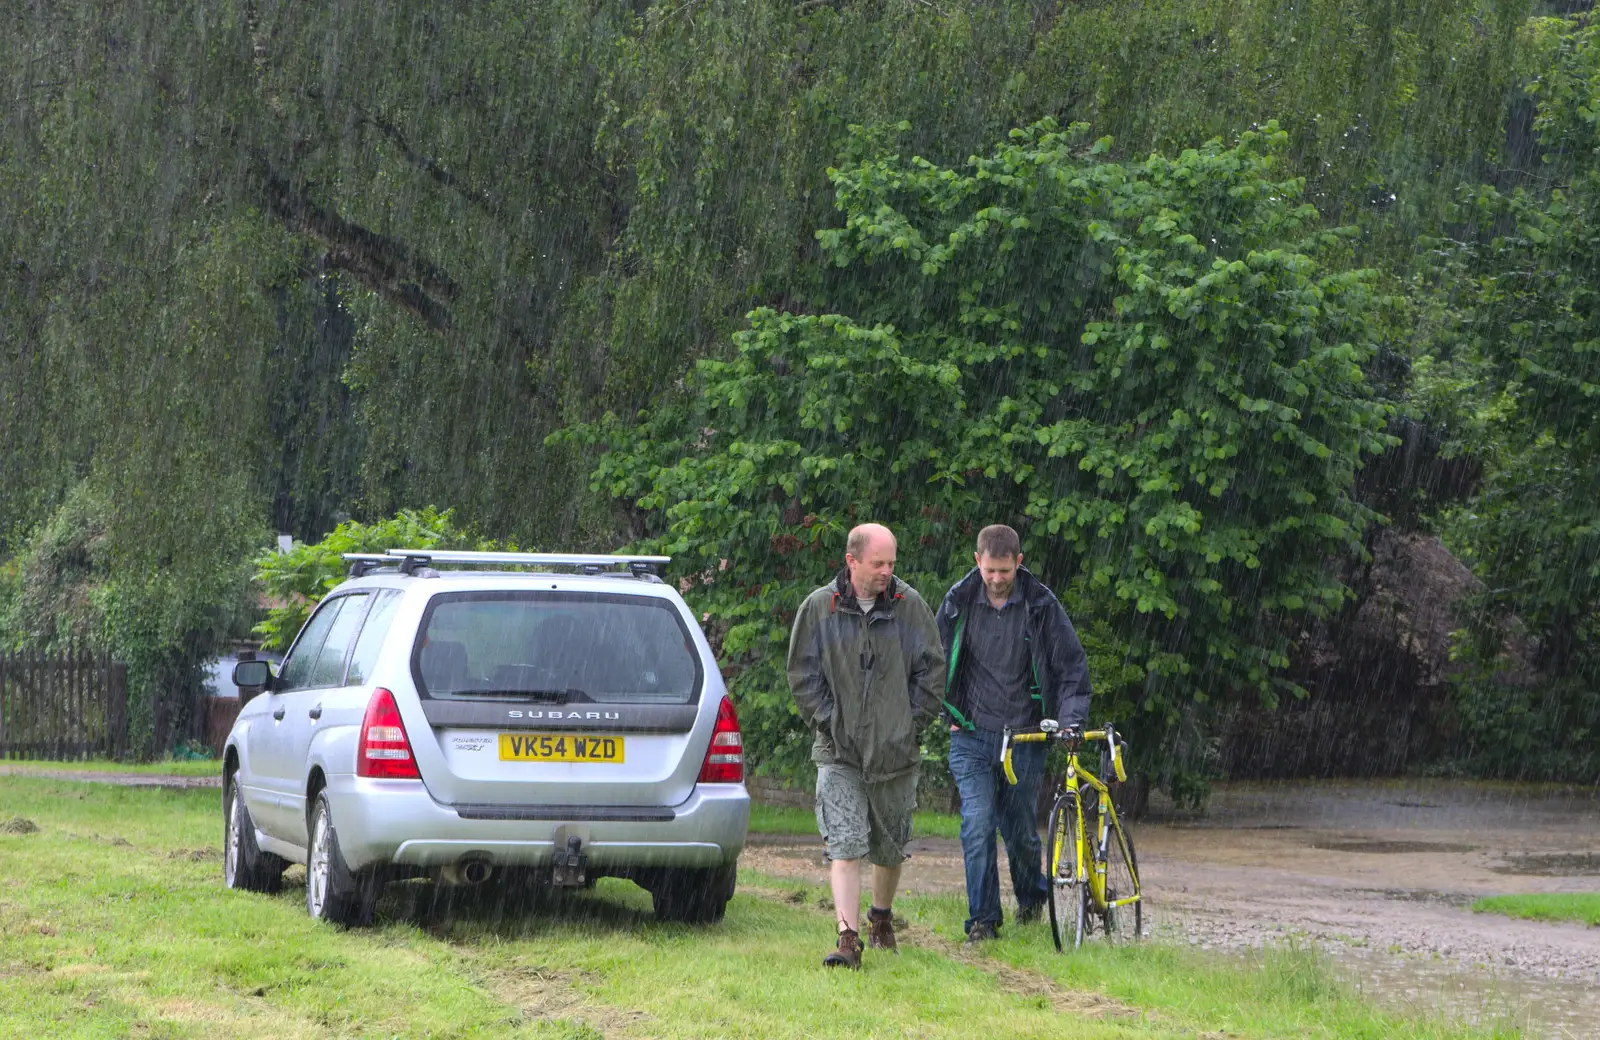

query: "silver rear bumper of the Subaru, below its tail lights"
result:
(326, 773), (750, 874)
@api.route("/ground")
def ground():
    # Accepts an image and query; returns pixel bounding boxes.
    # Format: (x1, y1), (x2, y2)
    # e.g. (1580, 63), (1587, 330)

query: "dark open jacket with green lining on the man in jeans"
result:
(938, 566), (1094, 730)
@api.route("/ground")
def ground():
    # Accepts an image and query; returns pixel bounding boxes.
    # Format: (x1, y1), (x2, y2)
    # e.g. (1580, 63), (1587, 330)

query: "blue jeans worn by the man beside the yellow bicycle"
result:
(950, 730), (1050, 931)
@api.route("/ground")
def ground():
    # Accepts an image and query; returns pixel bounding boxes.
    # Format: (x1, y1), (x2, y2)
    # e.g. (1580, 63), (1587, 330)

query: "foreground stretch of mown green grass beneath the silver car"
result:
(0, 776), (1504, 1040)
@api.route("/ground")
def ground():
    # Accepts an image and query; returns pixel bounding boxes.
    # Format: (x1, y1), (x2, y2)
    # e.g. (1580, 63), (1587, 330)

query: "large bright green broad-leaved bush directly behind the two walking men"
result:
(571, 120), (1387, 782)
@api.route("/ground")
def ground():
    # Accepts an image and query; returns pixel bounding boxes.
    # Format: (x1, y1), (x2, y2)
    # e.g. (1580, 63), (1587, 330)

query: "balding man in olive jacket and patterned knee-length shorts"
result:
(789, 523), (944, 968)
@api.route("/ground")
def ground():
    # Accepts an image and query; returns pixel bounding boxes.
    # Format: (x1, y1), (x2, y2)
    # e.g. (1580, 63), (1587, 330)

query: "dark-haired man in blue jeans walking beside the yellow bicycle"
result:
(938, 523), (1091, 944)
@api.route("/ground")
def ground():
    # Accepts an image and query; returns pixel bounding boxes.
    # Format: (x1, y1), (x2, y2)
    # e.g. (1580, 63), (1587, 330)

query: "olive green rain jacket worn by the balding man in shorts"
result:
(789, 570), (944, 781)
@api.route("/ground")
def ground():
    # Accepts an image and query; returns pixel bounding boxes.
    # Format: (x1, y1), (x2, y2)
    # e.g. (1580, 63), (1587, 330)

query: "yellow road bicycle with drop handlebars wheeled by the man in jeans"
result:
(1002, 720), (1144, 952)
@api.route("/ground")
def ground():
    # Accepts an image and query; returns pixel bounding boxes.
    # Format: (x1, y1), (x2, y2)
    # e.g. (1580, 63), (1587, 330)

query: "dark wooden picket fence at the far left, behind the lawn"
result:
(0, 650), (128, 760)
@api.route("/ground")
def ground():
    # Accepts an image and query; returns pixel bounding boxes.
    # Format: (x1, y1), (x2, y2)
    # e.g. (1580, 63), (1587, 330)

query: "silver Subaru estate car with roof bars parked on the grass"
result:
(222, 549), (750, 925)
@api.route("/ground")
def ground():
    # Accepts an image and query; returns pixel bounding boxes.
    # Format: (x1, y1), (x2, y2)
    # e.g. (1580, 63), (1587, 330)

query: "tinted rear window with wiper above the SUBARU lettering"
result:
(411, 592), (702, 704)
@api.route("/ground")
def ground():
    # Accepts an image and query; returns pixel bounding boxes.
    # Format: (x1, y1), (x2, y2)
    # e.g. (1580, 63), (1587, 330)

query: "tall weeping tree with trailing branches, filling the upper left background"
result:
(0, 0), (1523, 538)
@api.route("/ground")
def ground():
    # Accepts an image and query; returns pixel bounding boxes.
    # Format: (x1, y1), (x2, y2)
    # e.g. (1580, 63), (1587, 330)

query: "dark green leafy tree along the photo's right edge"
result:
(1427, 18), (1600, 778)
